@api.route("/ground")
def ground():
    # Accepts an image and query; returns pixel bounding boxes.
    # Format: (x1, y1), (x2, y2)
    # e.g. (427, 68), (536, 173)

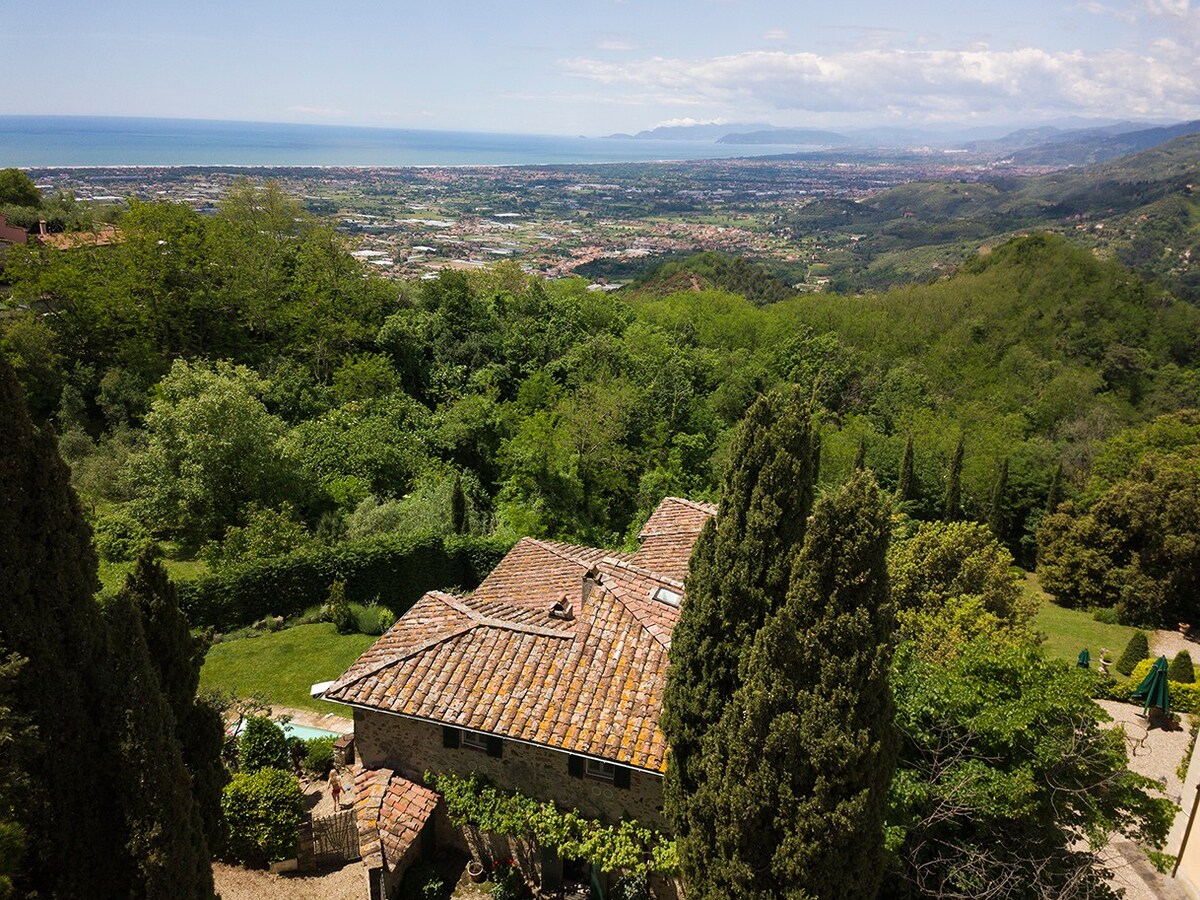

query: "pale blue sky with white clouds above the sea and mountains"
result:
(0, 0), (1200, 136)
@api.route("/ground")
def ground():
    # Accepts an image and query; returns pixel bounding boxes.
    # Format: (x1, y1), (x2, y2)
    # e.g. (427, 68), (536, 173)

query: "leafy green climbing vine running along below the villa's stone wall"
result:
(425, 773), (679, 876)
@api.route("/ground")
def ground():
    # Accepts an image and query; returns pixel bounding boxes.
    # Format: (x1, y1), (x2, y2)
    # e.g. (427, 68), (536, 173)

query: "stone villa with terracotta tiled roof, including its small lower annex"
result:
(324, 497), (716, 895)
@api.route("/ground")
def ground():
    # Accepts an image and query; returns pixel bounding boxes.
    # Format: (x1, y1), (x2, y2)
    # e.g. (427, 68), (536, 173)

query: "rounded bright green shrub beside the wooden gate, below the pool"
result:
(221, 763), (304, 868)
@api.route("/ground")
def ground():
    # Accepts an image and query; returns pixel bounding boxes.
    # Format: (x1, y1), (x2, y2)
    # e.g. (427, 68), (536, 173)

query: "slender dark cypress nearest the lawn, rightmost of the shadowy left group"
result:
(121, 553), (228, 848)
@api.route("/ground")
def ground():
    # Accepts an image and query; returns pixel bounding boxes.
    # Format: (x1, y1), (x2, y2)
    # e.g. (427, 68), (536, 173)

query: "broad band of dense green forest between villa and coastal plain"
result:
(0, 181), (1200, 620)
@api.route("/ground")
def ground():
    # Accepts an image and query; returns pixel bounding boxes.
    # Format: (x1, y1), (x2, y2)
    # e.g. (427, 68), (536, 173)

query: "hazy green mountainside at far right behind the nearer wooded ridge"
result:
(785, 134), (1200, 300)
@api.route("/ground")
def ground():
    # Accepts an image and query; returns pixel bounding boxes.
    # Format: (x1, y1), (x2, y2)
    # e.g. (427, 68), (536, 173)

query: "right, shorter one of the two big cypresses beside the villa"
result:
(683, 473), (898, 900)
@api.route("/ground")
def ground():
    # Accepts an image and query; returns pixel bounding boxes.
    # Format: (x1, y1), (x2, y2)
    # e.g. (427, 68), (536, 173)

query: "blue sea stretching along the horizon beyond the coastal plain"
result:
(0, 115), (812, 168)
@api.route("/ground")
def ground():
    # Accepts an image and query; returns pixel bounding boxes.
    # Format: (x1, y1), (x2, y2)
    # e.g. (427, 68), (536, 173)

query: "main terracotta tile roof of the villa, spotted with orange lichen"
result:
(324, 498), (715, 772)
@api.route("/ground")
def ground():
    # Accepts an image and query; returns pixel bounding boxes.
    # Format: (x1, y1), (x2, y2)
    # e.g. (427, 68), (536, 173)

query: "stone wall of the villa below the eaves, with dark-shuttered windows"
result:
(354, 709), (666, 838)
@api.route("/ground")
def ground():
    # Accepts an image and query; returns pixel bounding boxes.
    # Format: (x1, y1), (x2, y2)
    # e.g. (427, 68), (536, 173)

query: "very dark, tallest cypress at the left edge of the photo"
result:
(0, 358), (131, 898)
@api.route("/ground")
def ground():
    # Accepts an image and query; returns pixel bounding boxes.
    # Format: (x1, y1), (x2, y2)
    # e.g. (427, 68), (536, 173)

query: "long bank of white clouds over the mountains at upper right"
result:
(564, 41), (1200, 121)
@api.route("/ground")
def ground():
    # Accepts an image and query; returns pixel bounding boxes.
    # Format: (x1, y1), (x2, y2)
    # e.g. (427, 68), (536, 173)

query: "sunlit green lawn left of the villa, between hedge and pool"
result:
(200, 623), (378, 715)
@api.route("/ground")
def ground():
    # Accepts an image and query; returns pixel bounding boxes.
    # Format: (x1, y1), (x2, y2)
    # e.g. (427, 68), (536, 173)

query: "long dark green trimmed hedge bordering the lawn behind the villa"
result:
(178, 534), (511, 631)
